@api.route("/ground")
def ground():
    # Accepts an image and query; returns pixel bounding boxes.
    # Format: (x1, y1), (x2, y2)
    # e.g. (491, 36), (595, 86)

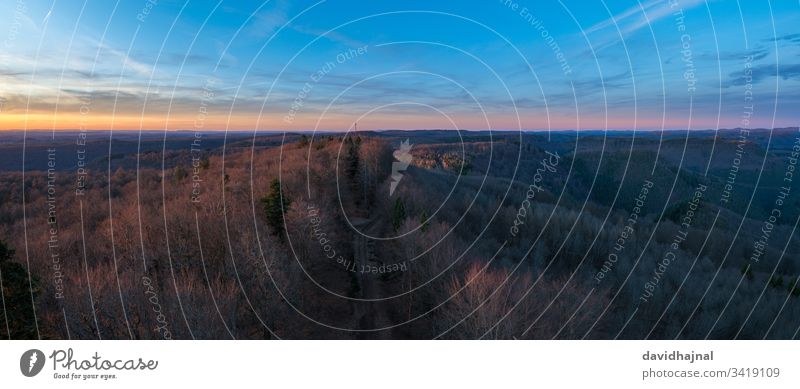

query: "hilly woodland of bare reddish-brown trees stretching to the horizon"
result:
(0, 128), (800, 339)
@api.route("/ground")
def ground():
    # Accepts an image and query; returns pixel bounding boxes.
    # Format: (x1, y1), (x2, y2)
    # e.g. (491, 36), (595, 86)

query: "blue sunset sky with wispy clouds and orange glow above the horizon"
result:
(0, 0), (800, 131)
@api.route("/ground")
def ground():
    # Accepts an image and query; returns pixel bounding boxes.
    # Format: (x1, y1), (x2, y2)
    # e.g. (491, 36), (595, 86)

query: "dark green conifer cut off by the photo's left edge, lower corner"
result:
(0, 241), (41, 339)
